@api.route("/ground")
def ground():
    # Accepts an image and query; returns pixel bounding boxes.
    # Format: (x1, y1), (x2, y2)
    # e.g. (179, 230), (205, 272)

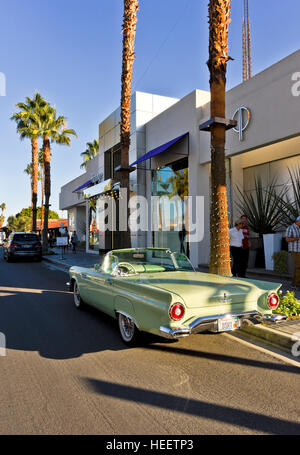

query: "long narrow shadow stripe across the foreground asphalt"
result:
(82, 378), (300, 435)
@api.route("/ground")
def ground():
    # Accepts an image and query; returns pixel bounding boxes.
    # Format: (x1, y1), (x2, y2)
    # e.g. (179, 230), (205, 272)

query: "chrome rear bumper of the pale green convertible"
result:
(160, 311), (287, 339)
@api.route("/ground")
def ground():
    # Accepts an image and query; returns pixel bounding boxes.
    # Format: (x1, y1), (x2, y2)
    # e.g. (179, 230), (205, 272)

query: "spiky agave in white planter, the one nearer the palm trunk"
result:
(236, 177), (287, 236)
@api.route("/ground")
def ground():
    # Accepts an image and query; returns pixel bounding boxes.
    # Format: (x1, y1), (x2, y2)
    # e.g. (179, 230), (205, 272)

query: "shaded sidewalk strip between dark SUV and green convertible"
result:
(43, 248), (103, 270)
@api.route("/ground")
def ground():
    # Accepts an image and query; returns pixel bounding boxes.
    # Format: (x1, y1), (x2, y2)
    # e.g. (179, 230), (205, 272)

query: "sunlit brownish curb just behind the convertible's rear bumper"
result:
(239, 325), (295, 354)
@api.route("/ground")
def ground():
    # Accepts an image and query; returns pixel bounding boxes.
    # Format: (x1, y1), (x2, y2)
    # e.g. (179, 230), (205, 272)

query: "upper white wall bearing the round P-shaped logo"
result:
(199, 50), (300, 163)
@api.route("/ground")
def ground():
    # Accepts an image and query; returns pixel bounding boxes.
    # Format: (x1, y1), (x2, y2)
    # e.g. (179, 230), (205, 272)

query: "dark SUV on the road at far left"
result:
(3, 232), (42, 262)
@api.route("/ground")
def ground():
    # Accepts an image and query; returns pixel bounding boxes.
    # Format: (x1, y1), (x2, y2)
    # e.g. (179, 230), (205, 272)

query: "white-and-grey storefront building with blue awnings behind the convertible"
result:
(60, 51), (300, 266)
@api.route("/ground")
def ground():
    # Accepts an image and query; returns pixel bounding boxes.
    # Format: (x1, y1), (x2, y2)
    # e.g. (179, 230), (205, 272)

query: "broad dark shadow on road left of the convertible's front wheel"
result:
(0, 286), (128, 359)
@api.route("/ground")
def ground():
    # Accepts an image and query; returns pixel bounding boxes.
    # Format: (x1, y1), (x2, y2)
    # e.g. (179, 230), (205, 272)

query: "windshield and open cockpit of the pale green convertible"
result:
(102, 248), (194, 274)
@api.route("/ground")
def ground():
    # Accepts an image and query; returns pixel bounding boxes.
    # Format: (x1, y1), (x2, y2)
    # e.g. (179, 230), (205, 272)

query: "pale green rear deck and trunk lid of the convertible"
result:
(140, 271), (281, 308)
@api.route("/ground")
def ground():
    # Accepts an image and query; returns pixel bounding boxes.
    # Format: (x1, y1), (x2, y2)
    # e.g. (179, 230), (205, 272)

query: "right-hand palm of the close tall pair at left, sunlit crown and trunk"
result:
(40, 104), (77, 251)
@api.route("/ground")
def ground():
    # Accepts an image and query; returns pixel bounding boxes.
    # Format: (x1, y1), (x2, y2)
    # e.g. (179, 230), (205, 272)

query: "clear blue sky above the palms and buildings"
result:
(0, 0), (300, 221)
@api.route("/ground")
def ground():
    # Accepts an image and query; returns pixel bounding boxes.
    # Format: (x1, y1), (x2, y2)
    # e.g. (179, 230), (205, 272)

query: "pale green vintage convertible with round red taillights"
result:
(67, 248), (284, 344)
